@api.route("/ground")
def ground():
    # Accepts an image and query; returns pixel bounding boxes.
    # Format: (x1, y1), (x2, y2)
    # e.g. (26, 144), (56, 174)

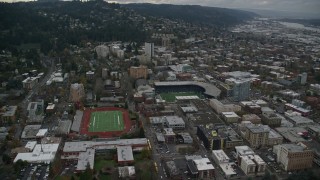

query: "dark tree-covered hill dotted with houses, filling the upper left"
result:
(0, 1), (146, 53)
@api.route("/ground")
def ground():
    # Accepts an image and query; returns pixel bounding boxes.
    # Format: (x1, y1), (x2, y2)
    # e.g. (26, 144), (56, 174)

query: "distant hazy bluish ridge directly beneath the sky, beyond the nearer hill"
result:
(122, 4), (258, 26)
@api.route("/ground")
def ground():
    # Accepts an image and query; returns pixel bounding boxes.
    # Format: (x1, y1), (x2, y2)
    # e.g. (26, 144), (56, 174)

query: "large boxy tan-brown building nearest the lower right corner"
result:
(274, 143), (314, 171)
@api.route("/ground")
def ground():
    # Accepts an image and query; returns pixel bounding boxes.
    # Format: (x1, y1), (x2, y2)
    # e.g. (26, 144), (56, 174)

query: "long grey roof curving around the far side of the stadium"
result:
(154, 81), (221, 97)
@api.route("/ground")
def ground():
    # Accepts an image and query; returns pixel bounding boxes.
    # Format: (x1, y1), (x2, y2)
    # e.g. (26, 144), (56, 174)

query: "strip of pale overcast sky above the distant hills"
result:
(109, 0), (320, 14)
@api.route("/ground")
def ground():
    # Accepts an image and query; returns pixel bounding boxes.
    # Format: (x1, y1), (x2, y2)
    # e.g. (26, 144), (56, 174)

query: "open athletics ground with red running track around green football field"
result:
(80, 107), (131, 138)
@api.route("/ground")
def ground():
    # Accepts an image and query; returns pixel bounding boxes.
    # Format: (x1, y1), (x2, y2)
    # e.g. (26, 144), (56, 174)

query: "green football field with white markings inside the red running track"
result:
(89, 111), (124, 132)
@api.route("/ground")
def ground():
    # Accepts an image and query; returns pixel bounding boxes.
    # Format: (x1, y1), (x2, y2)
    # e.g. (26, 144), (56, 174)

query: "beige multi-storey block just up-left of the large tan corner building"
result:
(244, 124), (270, 148)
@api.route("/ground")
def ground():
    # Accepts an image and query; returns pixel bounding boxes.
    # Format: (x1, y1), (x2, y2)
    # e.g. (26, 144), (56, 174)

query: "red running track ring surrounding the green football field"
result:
(80, 107), (131, 138)
